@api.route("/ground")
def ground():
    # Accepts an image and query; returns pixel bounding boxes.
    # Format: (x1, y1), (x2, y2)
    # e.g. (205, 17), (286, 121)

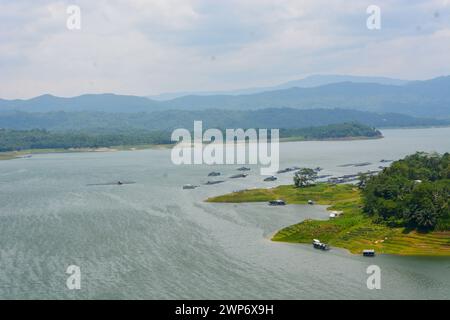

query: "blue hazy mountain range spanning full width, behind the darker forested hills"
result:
(0, 76), (450, 118)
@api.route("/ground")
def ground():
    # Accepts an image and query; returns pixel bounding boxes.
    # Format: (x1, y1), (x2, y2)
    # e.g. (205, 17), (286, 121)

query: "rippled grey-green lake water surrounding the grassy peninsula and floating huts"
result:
(0, 128), (450, 299)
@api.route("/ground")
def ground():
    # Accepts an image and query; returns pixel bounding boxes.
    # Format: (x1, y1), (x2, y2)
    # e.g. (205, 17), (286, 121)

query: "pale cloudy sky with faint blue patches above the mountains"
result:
(0, 0), (450, 99)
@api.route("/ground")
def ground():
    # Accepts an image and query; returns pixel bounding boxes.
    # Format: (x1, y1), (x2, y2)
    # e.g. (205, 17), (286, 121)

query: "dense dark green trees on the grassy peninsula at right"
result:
(361, 153), (450, 230)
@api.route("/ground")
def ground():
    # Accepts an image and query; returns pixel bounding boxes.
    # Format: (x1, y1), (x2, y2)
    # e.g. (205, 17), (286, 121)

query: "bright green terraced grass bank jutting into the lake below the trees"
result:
(207, 183), (450, 256)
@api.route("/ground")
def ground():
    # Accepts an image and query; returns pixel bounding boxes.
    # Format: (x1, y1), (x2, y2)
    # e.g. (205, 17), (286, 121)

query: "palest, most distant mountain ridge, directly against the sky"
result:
(149, 75), (408, 101)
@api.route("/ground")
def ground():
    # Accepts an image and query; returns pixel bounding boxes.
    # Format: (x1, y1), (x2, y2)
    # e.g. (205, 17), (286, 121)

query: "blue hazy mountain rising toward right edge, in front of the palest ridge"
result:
(160, 77), (450, 118)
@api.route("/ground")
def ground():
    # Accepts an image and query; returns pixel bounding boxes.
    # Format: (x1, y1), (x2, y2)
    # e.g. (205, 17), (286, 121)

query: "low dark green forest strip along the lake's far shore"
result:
(0, 123), (381, 152)
